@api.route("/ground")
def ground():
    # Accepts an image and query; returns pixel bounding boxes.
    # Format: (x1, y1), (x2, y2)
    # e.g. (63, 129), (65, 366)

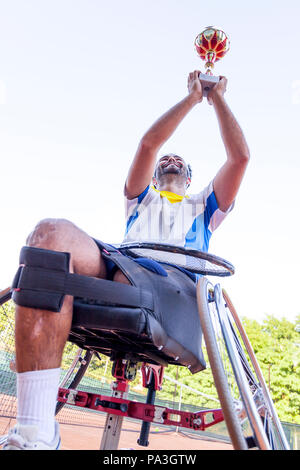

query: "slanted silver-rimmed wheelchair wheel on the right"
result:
(197, 278), (289, 450)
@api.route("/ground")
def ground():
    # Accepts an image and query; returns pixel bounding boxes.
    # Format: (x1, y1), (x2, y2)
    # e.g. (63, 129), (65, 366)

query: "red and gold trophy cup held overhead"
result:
(195, 26), (230, 96)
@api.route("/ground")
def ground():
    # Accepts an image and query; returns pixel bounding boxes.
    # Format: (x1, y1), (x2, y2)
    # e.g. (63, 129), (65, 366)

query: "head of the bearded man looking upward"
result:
(153, 153), (192, 193)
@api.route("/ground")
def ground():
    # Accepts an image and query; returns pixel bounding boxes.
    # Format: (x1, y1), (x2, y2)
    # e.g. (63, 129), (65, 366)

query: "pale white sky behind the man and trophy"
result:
(0, 0), (300, 320)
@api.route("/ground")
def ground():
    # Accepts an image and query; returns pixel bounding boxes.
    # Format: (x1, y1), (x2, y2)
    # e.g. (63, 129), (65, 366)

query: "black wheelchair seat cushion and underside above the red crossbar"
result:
(69, 290), (205, 374)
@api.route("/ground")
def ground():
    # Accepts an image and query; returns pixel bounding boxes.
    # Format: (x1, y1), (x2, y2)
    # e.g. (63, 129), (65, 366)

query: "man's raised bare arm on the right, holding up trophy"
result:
(208, 77), (250, 212)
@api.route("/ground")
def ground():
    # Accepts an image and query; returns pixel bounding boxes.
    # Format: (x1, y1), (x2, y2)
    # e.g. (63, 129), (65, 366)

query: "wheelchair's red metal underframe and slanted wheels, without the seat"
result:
(0, 242), (289, 450)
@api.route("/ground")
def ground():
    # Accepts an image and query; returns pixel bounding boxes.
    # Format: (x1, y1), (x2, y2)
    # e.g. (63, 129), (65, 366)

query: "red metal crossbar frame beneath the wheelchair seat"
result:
(58, 359), (224, 450)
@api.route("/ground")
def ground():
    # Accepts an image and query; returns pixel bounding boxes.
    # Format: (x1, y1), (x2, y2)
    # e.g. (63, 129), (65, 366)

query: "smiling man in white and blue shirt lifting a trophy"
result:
(4, 71), (249, 450)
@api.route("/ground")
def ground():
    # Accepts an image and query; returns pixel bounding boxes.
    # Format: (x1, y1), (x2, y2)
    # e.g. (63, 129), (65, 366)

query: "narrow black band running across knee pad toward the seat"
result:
(12, 266), (154, 310)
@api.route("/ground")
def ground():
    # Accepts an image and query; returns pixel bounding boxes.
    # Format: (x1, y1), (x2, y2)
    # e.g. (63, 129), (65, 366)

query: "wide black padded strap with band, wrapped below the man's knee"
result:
(12, 246), (154, 312)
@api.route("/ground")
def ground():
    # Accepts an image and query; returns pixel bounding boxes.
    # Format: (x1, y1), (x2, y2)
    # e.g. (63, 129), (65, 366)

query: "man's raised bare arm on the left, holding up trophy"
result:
(125, 70), (203, 199)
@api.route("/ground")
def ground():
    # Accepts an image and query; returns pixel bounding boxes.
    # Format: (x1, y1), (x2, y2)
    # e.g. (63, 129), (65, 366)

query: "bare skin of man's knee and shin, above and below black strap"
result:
(15, 219), (106, 372)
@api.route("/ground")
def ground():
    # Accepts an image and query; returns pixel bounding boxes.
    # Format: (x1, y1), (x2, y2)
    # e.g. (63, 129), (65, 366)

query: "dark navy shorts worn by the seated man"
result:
(86, 240), (205, 372)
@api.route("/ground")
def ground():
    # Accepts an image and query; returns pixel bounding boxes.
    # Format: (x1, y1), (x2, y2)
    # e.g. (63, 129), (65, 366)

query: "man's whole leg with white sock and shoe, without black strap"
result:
(6, 219), (129, 450)
